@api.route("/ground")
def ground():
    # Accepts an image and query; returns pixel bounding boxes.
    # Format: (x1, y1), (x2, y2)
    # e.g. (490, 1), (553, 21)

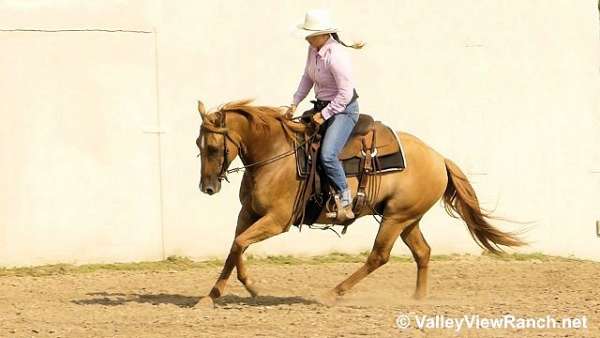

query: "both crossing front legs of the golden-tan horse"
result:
(196, 212), (285, 307)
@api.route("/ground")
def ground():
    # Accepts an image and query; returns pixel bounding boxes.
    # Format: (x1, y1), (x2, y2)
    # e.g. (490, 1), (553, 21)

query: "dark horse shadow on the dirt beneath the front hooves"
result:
(71, 292), (317, 308)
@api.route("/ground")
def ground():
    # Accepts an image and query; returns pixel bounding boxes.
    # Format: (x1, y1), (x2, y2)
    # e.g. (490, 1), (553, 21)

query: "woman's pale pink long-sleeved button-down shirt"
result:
(294, 36), (354, 120)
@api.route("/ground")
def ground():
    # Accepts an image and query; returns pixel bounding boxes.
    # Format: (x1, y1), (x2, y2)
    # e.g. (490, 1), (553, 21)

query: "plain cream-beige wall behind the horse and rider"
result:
(0, 0), (600, 265)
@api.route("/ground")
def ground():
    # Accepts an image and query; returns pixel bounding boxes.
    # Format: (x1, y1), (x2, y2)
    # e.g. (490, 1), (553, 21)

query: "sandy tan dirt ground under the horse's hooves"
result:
(0, 256), (600, 338)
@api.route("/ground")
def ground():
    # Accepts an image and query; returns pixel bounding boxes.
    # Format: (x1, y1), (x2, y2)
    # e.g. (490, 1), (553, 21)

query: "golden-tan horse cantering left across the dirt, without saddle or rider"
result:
(196, 100), (524, 306)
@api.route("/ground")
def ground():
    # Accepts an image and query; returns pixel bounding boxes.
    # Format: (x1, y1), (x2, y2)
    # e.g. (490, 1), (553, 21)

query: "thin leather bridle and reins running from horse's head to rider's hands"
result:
(196, 111), (318, 182)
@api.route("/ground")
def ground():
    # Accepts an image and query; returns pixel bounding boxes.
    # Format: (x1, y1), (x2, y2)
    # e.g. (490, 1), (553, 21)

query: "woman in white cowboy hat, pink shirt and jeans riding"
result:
(286, 9), (364, 222)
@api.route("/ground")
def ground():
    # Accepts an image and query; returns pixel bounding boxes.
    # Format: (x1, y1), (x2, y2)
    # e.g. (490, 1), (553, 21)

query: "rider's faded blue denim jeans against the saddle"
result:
(321, 100), (358, 204)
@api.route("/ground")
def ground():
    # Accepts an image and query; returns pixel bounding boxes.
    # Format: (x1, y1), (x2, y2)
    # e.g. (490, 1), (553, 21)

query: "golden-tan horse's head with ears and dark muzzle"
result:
(196, 101), (238, 195)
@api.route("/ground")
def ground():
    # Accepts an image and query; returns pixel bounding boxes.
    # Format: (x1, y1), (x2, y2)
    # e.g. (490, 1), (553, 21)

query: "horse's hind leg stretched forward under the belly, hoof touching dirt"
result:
(319, 217), (415, 305)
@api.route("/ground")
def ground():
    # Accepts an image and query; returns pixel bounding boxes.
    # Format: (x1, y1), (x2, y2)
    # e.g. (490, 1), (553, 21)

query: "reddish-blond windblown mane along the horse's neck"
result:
(207, 99), (306, 141)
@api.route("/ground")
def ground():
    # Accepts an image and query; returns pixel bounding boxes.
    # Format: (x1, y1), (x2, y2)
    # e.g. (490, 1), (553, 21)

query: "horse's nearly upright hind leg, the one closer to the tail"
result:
(401, 221), (431, 299)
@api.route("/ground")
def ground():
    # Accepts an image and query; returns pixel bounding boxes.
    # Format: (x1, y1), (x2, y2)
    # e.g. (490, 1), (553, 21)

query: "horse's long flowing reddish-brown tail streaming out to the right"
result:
(443, 159), (527, 254)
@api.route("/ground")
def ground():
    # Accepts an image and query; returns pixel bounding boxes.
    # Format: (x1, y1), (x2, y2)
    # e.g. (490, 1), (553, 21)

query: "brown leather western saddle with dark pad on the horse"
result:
(293, 109), (405, 234)
